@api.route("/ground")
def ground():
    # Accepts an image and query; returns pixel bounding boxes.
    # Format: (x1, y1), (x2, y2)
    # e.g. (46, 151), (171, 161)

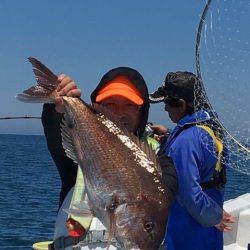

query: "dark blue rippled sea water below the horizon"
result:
(0, 135), (250, 250)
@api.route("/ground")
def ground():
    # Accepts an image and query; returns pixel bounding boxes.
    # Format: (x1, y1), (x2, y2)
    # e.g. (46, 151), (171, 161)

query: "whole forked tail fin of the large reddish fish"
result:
(16, 57), (59, 103)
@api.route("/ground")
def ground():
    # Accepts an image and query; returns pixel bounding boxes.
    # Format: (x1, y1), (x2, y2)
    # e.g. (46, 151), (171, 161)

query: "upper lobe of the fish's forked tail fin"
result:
(28, 57), (59, 91)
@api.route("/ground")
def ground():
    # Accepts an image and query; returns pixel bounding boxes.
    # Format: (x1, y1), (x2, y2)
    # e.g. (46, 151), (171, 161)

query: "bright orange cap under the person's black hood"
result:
(96, 75), (144, 105)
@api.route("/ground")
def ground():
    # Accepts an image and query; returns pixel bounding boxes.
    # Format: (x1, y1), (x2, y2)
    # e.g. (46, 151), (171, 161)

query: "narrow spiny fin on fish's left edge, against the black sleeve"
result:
(61, 117), (78, 163)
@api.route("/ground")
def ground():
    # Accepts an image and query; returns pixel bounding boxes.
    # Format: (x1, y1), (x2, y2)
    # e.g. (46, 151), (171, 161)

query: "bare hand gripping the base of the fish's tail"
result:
(55, 74), (81, 113)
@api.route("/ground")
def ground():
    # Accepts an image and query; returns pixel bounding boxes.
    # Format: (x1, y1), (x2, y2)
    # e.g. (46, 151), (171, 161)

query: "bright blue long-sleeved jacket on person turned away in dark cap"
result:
(161, 111), (224, 250)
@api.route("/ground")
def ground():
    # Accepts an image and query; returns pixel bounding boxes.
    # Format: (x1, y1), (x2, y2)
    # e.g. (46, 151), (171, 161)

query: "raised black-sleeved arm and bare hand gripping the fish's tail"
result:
(42, 74), (81, 207)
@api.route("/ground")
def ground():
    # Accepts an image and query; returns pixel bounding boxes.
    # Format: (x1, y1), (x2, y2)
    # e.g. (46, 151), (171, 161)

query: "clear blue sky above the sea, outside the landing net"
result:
(0, 0), (246, 137)
